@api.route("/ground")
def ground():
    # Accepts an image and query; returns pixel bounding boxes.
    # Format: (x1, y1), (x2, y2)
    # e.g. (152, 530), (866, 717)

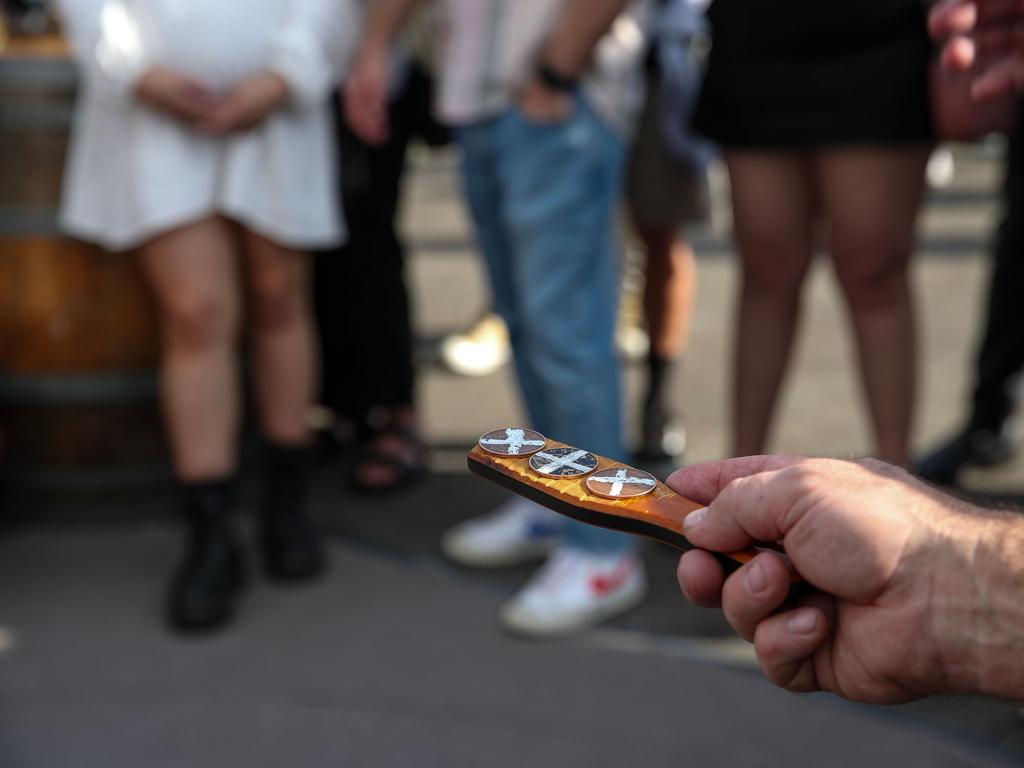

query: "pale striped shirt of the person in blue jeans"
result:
(437, 0), (647, 130)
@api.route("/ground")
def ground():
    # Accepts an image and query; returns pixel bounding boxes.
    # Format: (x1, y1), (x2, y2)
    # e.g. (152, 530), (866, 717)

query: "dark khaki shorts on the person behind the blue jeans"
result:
(626, 75), (711, 229)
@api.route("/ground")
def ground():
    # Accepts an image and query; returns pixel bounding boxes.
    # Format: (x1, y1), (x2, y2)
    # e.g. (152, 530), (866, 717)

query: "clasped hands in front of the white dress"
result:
(135, 67), (290, 136)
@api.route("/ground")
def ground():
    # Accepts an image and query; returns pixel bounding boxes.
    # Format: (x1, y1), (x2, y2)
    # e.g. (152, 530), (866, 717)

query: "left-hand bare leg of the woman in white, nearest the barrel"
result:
(141, 218), (241, 482)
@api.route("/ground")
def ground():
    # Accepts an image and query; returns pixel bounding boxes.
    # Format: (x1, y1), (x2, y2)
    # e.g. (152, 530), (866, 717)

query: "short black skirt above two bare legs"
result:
(696, 0), (933, 148)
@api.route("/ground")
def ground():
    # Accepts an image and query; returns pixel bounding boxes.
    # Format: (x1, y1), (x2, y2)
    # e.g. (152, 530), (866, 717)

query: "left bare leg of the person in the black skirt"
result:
(725, 151), (813, 456)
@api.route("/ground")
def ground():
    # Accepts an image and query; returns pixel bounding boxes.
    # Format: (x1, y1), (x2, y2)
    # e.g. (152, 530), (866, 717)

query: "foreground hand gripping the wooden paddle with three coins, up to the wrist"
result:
(668, 457), (977, 702)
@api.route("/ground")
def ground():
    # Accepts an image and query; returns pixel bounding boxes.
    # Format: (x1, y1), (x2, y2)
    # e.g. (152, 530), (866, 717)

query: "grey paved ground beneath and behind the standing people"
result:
(0, 141), (1024, 768)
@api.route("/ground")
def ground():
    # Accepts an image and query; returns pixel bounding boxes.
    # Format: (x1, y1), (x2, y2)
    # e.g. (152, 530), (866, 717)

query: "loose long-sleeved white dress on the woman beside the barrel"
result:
(60, 0), (358, 250)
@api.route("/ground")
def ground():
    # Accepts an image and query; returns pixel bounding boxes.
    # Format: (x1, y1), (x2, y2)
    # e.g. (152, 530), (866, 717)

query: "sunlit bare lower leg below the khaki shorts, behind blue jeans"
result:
(637, 225), (697, 359)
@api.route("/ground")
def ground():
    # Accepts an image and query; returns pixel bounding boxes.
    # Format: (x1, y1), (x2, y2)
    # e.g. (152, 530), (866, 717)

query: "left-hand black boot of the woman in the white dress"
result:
(168, 480), (245, 630)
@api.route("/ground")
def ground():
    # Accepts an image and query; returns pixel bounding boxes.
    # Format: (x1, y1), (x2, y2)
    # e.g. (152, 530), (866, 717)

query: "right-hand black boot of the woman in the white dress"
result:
(262, 443), (325, 581)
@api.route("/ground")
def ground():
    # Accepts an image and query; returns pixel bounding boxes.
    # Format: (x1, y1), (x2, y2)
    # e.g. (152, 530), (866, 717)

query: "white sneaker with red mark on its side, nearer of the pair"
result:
(501, 547), (647, 637)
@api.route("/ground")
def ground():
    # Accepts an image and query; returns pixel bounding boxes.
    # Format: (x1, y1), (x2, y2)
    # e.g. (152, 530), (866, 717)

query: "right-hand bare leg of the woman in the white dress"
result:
(244, 232), (318, 445)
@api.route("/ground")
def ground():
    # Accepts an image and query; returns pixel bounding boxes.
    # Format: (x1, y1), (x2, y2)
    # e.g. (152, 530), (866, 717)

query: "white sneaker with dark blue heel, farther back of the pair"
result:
(441, 496), (567, 567)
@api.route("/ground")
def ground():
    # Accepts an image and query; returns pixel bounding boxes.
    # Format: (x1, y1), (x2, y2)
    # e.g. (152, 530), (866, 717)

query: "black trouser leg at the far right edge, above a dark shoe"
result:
(970, 110), (1024, 430)
